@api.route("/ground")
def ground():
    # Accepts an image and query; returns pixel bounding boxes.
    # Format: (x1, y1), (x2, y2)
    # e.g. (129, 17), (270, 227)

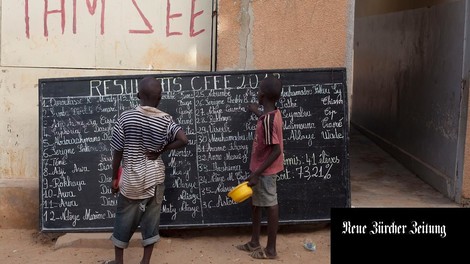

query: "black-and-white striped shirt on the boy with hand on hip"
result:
(111, 106), (181, 199)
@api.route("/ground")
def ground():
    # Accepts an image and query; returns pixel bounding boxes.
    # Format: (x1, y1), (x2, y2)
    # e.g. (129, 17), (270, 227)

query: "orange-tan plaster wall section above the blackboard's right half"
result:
(217, 0), (353, 70)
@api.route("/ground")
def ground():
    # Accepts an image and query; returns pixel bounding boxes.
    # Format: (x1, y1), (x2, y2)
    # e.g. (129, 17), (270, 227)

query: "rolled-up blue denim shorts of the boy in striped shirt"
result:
(110, 184), (165, 248)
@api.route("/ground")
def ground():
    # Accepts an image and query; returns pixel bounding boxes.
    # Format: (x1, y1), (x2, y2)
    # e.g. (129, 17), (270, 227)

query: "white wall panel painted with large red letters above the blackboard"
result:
(1, 0), (212, 70)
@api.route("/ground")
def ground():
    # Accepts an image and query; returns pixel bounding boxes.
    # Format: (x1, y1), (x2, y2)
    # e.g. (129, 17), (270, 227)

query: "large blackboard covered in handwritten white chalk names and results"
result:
(38, 68), (350, 232)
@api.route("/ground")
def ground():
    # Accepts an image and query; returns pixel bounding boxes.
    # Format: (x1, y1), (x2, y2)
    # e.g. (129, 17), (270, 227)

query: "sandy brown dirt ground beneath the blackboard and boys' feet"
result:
(0, 223), (330, 264)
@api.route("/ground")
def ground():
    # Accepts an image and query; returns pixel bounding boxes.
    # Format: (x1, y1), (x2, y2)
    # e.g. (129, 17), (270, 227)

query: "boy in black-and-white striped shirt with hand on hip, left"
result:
(106, 77), (188, 264)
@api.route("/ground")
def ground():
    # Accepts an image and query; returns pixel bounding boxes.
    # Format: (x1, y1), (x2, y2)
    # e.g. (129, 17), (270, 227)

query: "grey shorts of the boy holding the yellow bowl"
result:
(251, 175), (277, 207)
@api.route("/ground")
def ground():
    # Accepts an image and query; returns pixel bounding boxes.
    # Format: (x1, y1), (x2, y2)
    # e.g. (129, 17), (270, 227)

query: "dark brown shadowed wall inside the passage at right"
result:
(351, 0), (469, 201)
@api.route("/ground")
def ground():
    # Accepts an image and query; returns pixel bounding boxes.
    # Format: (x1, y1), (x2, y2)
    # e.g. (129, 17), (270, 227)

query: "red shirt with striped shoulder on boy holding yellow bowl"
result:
(250, 109), (284, 175)
